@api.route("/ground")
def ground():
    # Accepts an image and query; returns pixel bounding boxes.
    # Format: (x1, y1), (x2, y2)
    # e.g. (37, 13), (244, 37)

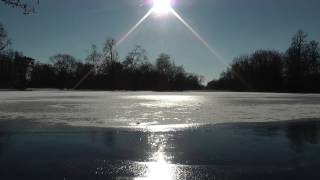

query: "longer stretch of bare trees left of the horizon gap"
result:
(0, 22), (203, 91)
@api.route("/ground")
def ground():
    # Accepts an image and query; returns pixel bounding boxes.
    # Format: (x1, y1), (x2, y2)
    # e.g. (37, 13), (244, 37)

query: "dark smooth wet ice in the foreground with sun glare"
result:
(0, 120), (320, 180)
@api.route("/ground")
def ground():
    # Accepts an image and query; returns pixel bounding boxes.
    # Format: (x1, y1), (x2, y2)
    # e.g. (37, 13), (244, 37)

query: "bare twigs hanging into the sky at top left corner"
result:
(0, 0), (40, 15)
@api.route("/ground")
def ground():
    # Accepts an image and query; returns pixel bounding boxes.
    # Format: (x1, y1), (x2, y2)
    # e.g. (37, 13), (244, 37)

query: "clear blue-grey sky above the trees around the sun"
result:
(0, 0), (320, 80)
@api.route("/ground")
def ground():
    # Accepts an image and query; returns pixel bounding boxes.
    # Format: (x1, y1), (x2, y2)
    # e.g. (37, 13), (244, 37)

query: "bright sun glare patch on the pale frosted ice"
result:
(122, 94), (204, 129)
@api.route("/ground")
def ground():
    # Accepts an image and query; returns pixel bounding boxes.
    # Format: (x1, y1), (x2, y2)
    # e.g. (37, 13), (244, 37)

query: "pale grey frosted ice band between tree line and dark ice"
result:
(0, 91), (320, 128)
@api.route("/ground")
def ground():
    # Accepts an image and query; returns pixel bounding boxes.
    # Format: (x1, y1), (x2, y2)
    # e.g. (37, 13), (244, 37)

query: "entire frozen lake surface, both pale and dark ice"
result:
(0, 91), (320, 180)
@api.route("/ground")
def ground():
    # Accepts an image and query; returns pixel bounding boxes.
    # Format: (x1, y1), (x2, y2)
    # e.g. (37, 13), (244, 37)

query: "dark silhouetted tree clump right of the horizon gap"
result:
(207, 30), (320, 92)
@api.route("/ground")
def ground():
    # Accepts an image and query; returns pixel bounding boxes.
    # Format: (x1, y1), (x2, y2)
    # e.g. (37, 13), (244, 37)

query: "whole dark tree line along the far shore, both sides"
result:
(0, 20), (320, 92)
